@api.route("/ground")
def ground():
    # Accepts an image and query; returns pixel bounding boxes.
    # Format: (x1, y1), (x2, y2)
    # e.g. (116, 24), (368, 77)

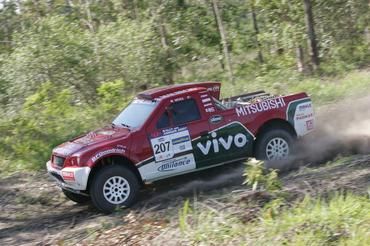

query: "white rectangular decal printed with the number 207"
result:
(150, 127), (192, 162)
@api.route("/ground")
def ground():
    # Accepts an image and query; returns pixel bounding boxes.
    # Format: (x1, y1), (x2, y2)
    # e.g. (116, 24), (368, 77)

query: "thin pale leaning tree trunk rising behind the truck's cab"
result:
(212, 0), (234, 84)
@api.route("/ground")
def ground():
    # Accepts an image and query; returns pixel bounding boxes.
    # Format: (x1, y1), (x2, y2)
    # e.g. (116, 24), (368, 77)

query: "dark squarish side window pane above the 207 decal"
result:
(171, 99), (200, 125)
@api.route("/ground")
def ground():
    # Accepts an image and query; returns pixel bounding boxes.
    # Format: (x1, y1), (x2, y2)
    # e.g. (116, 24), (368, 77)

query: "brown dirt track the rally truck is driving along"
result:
(0, 155), (370, 245)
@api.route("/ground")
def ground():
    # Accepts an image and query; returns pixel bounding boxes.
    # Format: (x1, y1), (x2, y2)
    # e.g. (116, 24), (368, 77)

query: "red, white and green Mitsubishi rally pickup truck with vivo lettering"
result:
(46, 82), (314, 213)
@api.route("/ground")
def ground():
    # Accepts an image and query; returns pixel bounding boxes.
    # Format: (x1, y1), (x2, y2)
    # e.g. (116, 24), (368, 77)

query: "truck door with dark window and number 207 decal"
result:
(140, 95), (209, 180)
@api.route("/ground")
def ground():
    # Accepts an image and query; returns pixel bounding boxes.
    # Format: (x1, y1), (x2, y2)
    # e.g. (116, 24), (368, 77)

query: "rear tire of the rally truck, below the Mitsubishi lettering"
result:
(255, 128), (295, 160)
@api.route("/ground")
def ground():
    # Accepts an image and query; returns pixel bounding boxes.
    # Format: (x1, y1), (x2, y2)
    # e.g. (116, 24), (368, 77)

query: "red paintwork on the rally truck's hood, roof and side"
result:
(52, 82), (308, 175)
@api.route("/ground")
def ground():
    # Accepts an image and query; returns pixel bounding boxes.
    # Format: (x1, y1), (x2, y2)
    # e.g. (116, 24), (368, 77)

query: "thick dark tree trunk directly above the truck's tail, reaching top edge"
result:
(303, 0), (320, 70)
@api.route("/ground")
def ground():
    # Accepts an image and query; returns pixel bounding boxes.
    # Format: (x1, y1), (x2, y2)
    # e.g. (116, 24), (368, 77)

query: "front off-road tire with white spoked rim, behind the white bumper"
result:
(89, 165), (140, 213)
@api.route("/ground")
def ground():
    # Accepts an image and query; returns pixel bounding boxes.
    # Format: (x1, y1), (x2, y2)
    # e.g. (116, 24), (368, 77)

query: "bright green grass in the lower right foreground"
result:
(176, 194), (370, 245)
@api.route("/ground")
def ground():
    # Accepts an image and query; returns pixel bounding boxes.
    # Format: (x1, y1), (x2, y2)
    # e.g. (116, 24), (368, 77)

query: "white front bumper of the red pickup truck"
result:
(46, 161), (91, 191)
